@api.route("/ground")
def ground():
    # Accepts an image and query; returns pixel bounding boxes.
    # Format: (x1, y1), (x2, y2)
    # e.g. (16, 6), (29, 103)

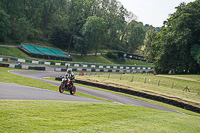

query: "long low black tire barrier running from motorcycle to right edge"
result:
(76, 80), (200, 113)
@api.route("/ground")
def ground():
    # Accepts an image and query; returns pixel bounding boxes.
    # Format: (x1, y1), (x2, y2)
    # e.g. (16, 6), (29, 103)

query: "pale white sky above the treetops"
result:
(118, 0), (195, 27)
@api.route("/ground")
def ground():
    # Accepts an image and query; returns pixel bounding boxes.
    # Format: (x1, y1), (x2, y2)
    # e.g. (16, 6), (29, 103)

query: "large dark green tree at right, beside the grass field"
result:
(151, 0), (200, 73)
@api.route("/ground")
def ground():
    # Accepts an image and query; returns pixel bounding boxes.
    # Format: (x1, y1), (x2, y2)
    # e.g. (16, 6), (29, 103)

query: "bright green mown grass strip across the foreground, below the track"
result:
(0, 101), (200, 133)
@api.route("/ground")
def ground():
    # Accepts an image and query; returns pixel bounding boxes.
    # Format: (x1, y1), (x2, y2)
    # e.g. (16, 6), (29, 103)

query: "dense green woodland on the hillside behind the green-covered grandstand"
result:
(0, 0), (159, 55)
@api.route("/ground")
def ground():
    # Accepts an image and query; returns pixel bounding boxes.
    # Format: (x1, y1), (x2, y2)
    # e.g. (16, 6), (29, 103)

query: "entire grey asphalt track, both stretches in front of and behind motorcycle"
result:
(0, 70), (181, 113)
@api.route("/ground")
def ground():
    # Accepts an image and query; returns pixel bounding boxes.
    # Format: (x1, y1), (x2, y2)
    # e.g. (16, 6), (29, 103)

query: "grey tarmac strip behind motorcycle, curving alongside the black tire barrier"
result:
(6, 70), (180, 113)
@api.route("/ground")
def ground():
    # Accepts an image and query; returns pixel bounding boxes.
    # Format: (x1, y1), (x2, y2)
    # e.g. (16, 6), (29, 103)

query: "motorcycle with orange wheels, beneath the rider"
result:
(59, 78), (76, 95)
